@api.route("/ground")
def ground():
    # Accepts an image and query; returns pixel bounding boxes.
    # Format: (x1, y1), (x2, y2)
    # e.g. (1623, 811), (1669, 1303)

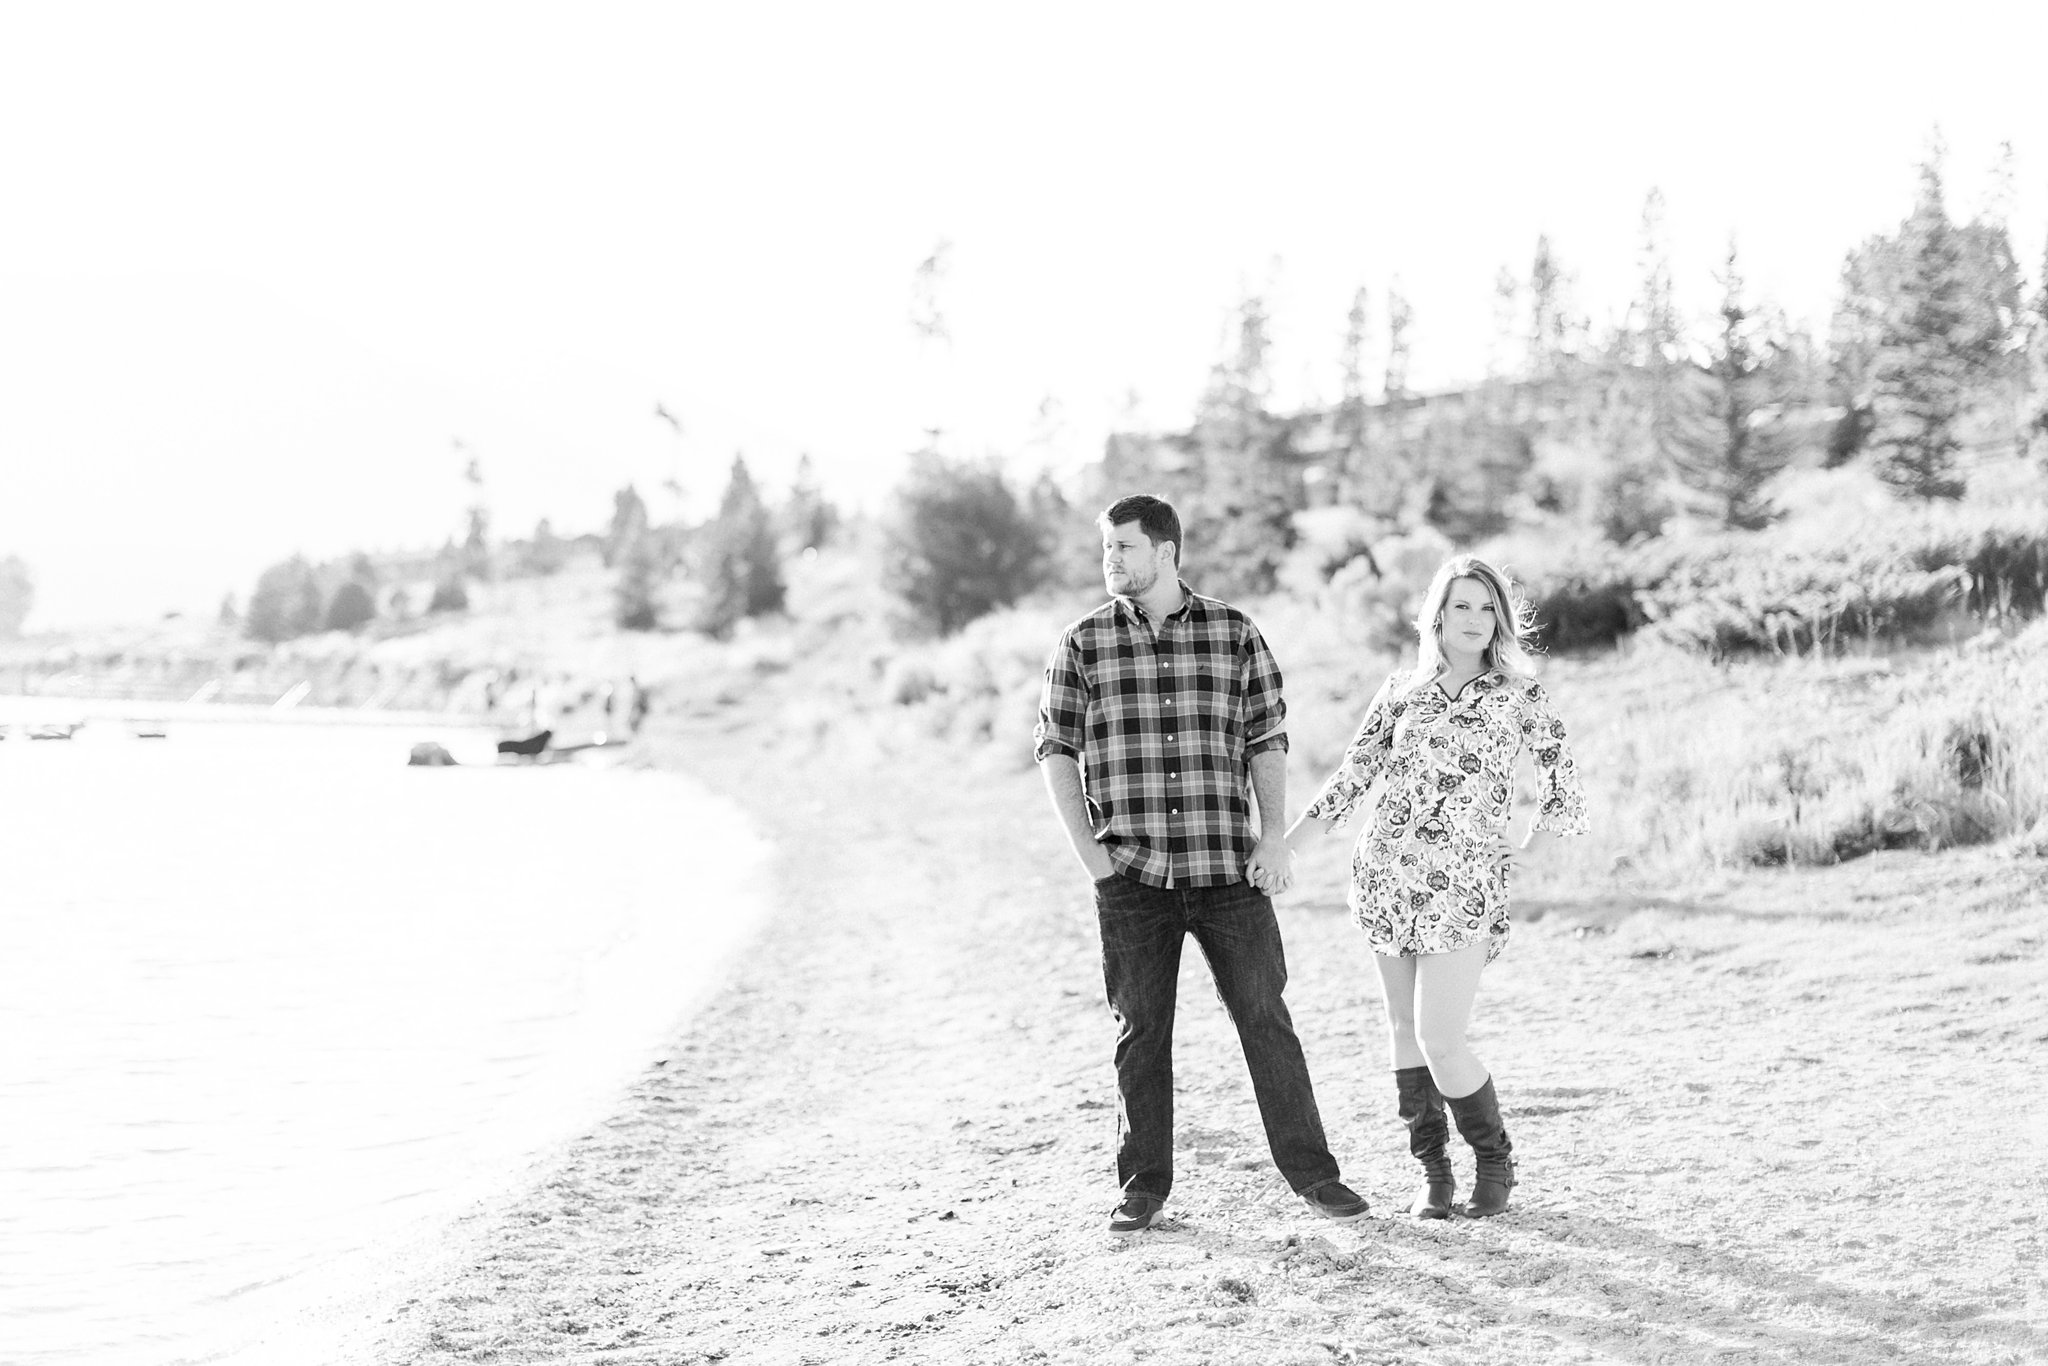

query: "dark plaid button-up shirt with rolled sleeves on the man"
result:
(1034, 584), (1286, 887)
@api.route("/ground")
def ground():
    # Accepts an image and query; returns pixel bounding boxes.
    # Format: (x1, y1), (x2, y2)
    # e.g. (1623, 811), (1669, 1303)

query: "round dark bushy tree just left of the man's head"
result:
(883, 451), (1044, 635)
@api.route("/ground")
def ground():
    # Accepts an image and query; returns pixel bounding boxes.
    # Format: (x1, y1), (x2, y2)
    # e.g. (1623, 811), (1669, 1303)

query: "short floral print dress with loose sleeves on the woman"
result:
(1309, 670), (1585, 963)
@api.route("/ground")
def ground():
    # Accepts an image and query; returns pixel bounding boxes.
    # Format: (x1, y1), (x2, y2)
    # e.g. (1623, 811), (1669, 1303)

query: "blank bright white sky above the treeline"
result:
(0, 0), (2048, 629)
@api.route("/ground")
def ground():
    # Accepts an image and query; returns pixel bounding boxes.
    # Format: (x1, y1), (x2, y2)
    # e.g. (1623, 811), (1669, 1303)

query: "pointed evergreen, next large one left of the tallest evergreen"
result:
(1673, 242), (1790, 530)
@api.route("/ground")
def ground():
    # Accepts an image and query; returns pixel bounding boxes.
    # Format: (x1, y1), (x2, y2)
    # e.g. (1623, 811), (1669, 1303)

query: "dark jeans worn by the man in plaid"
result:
(1096, 874), (1337, 1200)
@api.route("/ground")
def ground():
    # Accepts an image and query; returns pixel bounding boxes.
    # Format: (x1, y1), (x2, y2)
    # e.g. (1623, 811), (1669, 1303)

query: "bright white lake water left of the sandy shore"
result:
(0, 723), (766, 1366)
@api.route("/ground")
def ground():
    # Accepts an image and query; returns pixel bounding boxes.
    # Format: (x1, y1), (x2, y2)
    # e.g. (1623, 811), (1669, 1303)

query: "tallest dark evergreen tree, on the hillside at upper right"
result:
(1872, 160), (1970, 500)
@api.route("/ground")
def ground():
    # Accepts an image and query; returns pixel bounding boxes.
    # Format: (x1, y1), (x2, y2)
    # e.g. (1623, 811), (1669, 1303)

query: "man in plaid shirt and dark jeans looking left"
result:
(1036, 494), (1366, 1233)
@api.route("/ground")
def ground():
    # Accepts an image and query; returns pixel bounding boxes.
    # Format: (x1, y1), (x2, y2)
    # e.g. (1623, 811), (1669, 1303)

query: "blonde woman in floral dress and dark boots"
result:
(1288, 555), (1585, 1219)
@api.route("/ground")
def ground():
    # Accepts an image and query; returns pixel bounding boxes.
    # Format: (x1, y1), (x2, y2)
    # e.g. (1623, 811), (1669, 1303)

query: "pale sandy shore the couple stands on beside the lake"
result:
(344, 671), (2048, 1366)
